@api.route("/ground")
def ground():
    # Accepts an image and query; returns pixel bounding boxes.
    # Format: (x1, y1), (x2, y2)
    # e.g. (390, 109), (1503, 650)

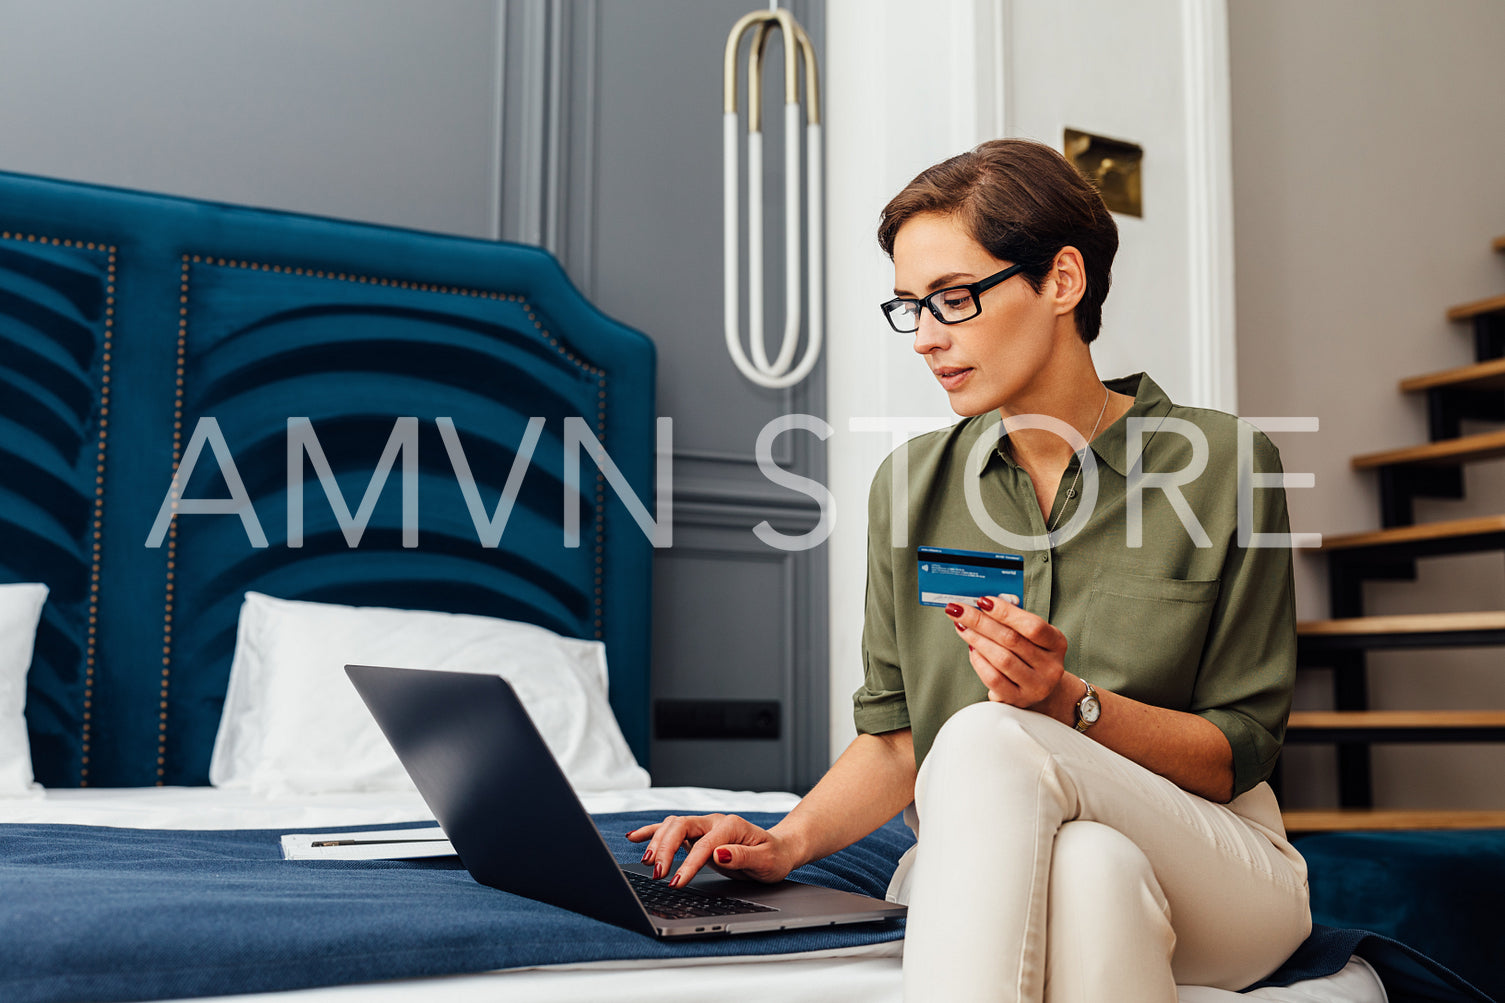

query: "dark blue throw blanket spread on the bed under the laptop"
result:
(0, 812), (1487, 1003)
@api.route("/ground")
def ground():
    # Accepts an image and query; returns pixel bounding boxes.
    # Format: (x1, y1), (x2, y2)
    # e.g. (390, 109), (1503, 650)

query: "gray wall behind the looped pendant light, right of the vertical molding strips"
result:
(586, 0), (829, 788)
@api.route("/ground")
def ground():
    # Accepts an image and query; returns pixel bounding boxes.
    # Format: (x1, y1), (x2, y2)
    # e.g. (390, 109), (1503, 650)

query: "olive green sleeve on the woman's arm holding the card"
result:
(1190, 432), (1296, 797)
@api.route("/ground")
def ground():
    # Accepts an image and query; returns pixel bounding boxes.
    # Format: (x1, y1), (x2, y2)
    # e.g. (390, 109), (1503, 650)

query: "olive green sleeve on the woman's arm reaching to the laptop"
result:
(852, 458), (909, 735)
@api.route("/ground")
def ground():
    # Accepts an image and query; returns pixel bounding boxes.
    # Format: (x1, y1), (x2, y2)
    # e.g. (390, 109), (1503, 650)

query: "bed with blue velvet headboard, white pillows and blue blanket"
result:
(0, 167), (1482, 1003)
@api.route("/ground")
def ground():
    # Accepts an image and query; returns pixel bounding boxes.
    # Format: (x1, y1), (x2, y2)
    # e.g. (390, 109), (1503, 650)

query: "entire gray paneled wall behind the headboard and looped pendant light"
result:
(0, 0), (826, 788)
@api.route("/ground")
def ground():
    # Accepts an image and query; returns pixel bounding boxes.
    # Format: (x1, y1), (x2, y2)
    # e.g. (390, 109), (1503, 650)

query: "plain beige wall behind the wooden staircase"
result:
(1230, 0), (1505, 809)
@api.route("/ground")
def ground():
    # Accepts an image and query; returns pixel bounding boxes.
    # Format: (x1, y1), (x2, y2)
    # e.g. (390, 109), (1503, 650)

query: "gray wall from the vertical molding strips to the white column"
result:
(492, 0), (829, 789)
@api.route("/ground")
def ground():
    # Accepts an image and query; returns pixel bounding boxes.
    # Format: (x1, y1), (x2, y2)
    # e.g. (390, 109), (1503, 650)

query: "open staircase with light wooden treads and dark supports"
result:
(1285, 236), (1505, 833)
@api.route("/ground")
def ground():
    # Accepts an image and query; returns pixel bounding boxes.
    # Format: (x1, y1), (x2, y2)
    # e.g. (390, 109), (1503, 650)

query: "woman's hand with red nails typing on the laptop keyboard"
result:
(628, 813), (802, 887)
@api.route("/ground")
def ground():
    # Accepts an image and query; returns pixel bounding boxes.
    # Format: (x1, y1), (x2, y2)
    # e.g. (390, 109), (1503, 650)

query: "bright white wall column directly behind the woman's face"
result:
(826, 0), (1010, 758)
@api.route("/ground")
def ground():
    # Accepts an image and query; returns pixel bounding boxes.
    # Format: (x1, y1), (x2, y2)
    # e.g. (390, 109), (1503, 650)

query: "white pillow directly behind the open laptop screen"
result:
(209, 592), (649, 797)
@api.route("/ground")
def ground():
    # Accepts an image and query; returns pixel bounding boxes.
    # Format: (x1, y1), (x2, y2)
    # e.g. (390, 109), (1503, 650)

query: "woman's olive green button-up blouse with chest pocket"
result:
(853, 373), (1296, 797)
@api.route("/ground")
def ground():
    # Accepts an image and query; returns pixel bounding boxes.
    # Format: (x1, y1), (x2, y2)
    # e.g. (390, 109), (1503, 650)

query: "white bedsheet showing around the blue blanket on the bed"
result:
(0, 788), (1386, 1003)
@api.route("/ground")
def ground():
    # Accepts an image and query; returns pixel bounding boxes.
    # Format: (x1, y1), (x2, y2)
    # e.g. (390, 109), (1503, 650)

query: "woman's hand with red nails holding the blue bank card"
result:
(945, 595), (1081, 724)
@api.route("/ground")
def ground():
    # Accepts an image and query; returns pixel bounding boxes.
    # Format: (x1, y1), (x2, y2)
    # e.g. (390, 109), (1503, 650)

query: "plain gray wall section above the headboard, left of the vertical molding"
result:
(0, 0), (497, 236)
